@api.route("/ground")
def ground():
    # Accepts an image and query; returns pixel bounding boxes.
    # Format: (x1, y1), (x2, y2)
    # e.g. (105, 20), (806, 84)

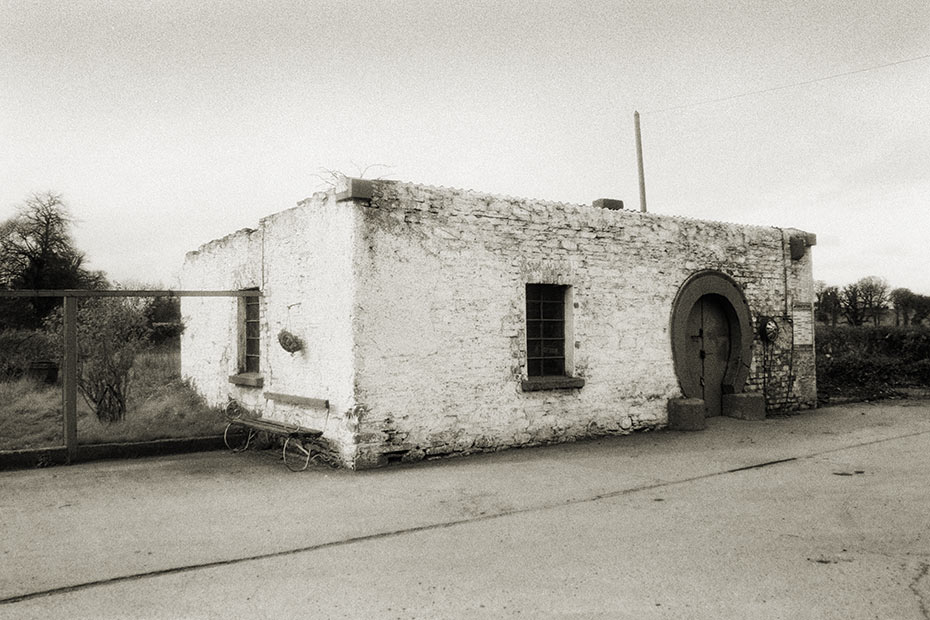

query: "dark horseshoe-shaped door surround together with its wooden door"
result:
(671, 271), (753, 416)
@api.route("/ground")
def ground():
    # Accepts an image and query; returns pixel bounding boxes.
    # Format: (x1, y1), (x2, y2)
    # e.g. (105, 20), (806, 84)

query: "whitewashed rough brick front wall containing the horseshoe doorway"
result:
(355, 182), (812, 466)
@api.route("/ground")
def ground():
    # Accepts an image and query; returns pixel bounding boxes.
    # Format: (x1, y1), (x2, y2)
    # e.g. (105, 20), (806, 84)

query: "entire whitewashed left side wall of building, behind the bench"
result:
(181, 194), (358, 465)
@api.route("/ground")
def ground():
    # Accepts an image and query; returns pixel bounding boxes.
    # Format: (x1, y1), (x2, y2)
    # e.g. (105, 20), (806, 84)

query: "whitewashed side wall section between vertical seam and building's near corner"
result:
(261, 193), (358, 463)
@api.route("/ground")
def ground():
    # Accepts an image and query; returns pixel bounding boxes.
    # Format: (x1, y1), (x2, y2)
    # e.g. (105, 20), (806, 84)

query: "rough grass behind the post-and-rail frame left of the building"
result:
(0, 347), (225, 450)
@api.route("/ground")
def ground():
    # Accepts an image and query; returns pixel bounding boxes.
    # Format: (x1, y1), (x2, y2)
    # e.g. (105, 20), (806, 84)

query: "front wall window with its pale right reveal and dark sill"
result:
(522, 284), (584, 392)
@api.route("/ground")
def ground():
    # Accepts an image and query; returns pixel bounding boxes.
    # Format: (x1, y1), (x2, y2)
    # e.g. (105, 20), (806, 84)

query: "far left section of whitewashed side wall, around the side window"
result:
(181, 229), (266, 409)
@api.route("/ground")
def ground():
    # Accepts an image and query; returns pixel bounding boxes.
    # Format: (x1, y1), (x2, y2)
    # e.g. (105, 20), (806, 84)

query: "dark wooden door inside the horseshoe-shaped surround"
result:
(687, 295), (732, 416)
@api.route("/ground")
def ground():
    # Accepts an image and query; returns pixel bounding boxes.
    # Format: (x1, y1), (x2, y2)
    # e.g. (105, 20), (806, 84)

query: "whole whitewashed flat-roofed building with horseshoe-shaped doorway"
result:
(182, 179), (816, 468)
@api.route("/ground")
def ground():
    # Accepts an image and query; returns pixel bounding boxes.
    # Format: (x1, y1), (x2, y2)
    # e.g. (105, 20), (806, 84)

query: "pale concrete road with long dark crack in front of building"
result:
(0, 401), (930, 619)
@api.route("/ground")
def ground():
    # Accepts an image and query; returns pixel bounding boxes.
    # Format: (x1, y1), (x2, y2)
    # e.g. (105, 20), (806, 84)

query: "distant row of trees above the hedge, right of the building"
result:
(814, 276), (930, 327)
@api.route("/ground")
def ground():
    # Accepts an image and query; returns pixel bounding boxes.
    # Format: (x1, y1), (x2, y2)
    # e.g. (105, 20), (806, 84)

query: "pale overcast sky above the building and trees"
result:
(0, 0), (930, 294)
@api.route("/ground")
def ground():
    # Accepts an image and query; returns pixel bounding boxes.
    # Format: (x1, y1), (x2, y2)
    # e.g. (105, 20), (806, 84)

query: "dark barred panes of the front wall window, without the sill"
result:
(526, 284), (567, 377)
